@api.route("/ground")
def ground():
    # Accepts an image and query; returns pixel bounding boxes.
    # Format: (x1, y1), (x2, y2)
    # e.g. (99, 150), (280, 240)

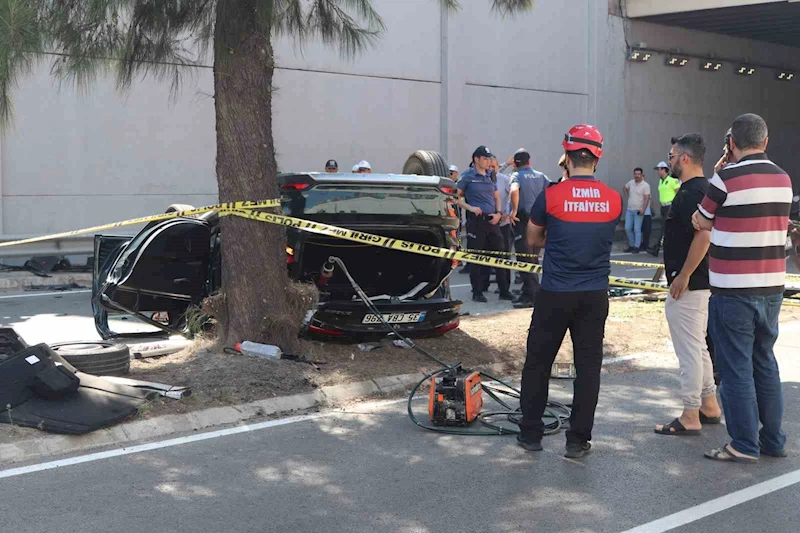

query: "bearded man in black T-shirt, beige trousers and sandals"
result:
(655, 133), (722, 436)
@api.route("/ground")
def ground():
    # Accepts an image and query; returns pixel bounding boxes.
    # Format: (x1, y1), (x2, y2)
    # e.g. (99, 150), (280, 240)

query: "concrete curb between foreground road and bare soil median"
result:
(0, 363), (509, 464)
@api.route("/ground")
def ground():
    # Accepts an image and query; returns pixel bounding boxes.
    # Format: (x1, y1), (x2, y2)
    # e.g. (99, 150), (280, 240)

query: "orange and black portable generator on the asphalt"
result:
(428, 365), (483, 426)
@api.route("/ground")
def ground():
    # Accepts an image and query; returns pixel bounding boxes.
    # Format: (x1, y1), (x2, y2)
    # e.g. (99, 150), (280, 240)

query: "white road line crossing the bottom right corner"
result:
(622, 470), (800, 533)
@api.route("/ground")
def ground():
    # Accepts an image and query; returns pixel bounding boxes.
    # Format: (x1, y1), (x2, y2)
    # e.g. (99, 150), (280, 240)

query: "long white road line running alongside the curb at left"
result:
(0, 398), (407, 479)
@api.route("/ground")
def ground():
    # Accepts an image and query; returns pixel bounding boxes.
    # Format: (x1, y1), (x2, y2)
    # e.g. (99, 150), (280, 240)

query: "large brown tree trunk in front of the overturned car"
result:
(206, 0), (309, 353)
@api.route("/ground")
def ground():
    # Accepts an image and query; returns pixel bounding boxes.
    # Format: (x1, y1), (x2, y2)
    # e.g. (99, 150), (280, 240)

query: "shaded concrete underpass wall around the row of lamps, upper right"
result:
(602, 19), (800, 204)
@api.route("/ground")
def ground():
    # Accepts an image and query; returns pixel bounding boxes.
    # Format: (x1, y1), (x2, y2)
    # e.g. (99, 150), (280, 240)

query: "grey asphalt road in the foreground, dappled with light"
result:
(0, 340), (800, 533)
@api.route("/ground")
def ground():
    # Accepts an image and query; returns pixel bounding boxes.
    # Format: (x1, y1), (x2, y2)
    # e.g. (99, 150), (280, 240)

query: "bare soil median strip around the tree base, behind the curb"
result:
(131, 301), (688, 416)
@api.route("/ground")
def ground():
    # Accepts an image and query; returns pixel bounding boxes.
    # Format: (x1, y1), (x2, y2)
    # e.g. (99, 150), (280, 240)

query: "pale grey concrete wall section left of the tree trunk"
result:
(0, 64), (217, 235)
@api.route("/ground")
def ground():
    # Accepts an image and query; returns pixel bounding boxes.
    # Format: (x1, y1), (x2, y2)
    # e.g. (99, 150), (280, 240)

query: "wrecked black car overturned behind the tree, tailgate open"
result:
(92, 162), (461, 341)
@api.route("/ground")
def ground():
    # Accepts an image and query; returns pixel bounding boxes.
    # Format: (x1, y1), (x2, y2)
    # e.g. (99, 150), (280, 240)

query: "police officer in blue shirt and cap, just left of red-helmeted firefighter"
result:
(509, 148), (548, 309)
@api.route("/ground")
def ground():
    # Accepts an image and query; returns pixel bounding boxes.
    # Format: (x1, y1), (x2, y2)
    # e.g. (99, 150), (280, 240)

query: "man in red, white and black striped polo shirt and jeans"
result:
(692, 114), (792, 463)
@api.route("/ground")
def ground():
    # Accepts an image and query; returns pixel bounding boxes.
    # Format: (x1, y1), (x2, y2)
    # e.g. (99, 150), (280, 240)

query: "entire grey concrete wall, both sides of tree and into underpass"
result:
(0, 0), (800, 249)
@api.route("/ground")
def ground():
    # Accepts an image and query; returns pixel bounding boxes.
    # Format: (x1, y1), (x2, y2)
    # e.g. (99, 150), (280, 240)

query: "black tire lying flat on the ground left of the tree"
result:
(50, 341), (131, 376)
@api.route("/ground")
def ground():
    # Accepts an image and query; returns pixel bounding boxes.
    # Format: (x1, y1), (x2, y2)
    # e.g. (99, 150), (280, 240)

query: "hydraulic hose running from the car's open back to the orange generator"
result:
(328, 256), (572, 437)
